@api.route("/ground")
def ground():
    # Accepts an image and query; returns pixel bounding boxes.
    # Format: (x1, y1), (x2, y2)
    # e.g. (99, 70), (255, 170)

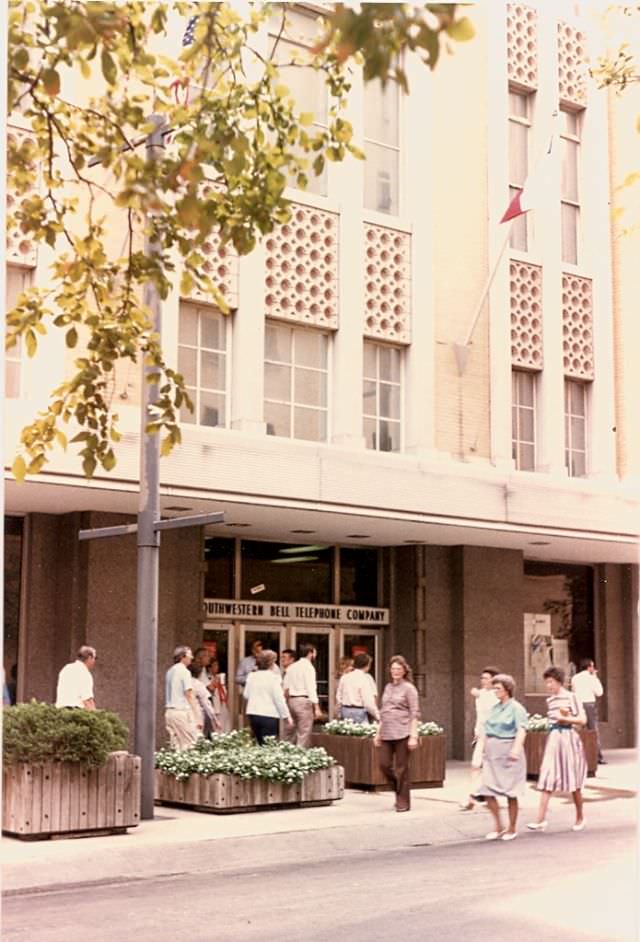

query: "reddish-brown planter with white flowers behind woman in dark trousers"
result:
(313, 720), (446, 789)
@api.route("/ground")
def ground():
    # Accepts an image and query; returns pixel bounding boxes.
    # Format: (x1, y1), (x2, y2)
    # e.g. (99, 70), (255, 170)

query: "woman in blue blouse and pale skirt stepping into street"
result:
(478, 674), (527, 841)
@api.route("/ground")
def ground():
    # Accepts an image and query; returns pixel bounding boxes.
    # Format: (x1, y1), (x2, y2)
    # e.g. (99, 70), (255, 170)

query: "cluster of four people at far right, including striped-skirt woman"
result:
(462, 659), (605, 841)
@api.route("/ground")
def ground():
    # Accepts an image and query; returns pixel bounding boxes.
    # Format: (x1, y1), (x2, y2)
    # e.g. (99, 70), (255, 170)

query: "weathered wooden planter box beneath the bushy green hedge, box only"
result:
(2, 752), (140, 840)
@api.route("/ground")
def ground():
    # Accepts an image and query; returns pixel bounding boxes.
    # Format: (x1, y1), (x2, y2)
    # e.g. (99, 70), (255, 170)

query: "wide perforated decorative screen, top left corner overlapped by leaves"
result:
(265, 203), (338, 330)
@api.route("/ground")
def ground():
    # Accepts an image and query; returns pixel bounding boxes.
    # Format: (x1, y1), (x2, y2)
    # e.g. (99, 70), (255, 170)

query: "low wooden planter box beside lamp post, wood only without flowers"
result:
(156, 765), (344, 814)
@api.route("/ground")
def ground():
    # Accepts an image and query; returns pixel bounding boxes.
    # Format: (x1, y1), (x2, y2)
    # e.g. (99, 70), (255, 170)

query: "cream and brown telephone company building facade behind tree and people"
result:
(5, 3), (640, 757)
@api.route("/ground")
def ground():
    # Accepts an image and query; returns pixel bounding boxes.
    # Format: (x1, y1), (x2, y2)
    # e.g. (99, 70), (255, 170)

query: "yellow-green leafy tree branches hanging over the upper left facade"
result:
(7, 0), (473, 479)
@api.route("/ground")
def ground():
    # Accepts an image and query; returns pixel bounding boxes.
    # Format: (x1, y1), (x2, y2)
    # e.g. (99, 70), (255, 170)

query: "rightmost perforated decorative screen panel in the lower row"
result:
(562, 274), (594, 379)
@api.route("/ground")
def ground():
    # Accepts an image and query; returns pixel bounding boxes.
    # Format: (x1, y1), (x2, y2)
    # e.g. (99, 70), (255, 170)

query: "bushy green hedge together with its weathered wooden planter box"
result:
(2, 701), (140, 838)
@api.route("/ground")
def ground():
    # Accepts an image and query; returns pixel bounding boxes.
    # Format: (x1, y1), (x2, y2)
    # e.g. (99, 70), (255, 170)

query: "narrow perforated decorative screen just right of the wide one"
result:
(364, 223), (411, 344)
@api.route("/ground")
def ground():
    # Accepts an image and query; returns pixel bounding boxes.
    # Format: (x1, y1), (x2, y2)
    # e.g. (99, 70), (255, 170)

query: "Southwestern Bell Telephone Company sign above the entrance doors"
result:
(204, 599), (389, 626)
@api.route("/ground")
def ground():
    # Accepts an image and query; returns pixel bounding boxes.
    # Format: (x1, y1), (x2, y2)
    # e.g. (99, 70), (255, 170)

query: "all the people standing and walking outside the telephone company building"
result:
(48, 640), (605, 841)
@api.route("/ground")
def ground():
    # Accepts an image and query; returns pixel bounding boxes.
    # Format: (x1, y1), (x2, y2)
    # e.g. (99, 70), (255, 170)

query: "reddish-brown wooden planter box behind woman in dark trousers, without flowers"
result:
(312, 733), (446, 790)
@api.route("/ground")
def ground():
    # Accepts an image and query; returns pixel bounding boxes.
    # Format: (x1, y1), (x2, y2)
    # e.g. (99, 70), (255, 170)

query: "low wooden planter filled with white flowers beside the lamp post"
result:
(156, 731), (344, 813)
